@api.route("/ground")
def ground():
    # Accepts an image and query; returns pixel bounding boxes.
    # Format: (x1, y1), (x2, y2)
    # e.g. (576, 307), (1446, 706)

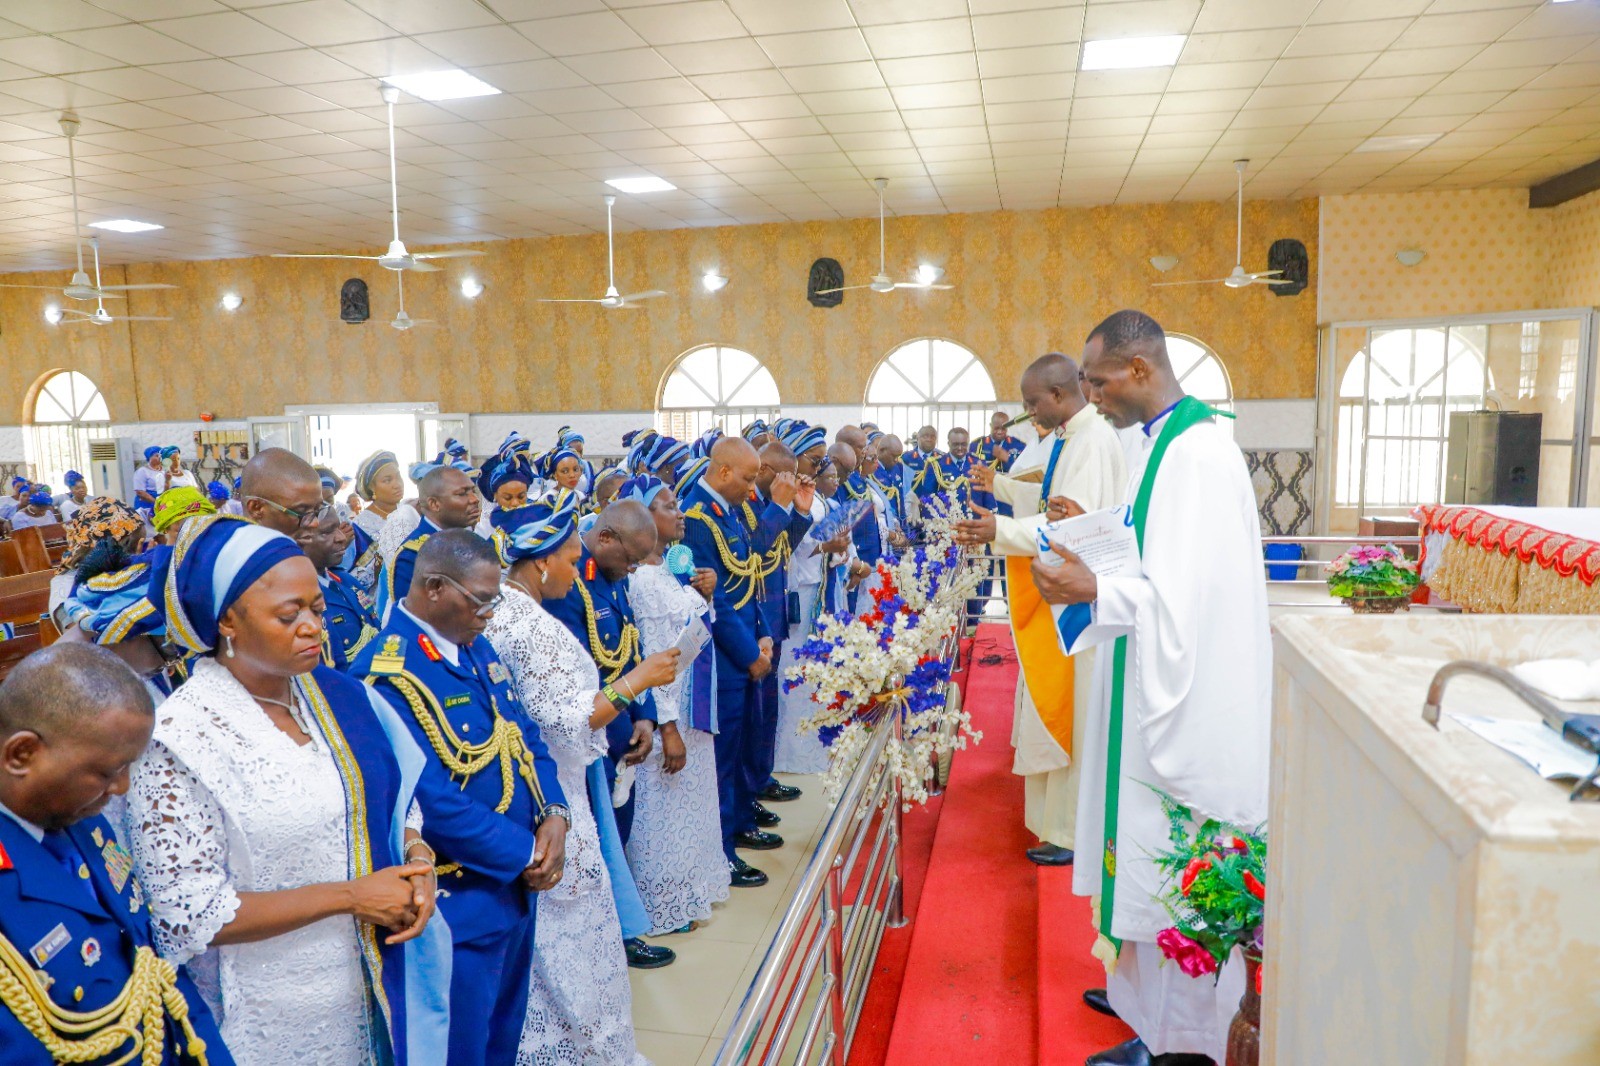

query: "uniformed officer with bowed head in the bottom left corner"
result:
(0, 643), (234, 1066)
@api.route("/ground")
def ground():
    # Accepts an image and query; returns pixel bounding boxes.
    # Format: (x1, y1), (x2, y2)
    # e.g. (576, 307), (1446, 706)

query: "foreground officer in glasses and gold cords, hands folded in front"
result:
(350, 530), (570, 1066)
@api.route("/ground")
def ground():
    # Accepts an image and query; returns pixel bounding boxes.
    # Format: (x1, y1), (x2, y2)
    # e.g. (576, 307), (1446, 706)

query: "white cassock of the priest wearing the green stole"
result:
(1072, 403), (1272, 1063)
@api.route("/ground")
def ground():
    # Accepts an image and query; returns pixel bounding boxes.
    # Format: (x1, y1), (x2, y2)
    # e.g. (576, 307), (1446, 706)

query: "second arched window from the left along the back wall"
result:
(656, 344), (778, 440)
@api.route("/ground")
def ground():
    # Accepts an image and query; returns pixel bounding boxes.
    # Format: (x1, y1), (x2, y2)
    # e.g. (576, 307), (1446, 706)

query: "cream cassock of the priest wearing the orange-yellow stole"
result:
(992, 403), (1128, 848)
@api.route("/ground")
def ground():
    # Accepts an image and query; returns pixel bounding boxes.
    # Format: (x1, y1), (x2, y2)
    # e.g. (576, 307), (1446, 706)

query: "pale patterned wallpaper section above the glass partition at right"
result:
(1317, 189), (1550, 322)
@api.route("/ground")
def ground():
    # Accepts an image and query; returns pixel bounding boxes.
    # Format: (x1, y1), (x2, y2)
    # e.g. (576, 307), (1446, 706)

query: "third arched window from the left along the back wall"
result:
(862, 338), (995, 448)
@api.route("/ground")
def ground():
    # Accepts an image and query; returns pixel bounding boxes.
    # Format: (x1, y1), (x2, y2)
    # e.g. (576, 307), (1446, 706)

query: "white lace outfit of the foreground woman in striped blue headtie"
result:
(128, 659), (371, 1066)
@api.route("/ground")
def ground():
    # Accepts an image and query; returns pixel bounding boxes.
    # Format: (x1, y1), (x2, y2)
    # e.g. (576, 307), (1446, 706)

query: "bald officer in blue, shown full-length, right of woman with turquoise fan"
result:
(680, 437), (782, 888)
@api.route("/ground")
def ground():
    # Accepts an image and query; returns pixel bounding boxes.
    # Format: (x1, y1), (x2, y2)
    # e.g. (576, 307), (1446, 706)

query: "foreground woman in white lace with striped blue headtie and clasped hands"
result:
(128, 515), (450, 1066)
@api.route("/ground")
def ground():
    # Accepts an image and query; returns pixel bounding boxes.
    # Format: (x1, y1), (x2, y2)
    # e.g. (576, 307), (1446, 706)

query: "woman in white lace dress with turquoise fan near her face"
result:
(618, 475), (728, 935)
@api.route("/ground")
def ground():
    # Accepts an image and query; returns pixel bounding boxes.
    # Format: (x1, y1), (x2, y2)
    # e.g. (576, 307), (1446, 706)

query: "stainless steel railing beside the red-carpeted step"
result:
(715, 634), (960, 1066)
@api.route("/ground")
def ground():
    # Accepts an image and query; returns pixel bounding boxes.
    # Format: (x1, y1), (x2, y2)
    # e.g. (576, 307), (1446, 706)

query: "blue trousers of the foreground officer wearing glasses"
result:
(450, 908), (536, 1066)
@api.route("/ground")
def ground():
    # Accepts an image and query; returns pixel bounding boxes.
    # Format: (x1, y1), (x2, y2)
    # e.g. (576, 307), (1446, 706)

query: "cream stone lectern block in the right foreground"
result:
(1261, 615), (1600, 1066)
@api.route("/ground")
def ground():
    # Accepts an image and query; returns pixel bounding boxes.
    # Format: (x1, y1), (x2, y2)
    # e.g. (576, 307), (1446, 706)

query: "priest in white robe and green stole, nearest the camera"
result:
(1034, 311), (1272, 1066)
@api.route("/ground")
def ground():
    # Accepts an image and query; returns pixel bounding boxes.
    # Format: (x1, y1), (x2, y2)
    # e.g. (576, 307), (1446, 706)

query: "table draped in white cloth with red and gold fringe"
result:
(1414, 504), (1600, 615)
